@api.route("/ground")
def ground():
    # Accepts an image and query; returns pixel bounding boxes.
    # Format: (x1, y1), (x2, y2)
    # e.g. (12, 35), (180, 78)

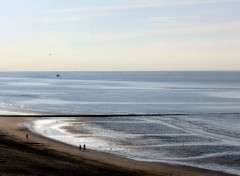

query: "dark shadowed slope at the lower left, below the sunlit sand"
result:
(0, 133), (139, 176)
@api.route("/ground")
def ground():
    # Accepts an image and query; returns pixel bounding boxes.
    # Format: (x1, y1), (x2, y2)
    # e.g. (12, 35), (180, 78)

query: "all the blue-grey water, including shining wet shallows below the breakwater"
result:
(0, 72), (240, 175)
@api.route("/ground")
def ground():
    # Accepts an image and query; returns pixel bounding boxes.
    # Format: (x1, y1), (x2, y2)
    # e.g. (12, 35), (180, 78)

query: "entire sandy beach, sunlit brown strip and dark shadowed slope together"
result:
(0, 117), (235, 176)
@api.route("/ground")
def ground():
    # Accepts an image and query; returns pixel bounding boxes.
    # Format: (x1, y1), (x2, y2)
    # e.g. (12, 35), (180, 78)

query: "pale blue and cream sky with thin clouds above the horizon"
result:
(0, 0), (240, 71)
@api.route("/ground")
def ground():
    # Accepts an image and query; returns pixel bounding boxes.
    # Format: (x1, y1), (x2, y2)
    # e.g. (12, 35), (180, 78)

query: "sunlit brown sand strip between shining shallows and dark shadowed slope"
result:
(0, 116), (233, 176)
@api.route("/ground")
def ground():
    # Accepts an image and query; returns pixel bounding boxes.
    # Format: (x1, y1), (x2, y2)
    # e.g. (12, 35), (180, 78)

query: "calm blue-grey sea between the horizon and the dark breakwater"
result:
(0, 72), (240, 114)
